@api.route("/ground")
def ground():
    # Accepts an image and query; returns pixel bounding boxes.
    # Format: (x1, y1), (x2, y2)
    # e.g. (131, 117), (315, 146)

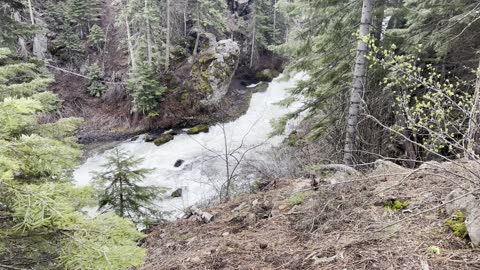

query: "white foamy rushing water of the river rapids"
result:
(74, 75), (301, 217)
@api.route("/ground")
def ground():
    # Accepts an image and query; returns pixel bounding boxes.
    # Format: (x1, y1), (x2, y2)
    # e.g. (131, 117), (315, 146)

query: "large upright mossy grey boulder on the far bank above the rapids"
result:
(191, 36), (240, 106)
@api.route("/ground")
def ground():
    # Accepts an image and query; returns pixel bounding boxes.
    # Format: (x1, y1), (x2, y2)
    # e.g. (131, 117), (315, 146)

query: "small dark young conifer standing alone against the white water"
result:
(94, 148), (163, 225)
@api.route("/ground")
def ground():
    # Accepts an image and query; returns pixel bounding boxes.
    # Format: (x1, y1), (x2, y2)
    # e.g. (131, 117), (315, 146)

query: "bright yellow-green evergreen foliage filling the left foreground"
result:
(0, 48), (146, 269)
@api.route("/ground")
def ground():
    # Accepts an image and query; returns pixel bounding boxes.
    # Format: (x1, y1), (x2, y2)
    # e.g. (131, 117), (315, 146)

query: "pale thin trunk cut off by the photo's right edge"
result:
(465, 58), (480, 157)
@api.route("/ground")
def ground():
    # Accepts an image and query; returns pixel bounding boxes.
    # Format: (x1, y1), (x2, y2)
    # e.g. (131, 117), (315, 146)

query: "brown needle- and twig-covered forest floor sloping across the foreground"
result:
(142, 161), (480, 270)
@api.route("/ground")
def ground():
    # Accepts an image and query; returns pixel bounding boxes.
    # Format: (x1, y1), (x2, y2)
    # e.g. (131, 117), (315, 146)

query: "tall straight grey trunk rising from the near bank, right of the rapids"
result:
(343, 0), (373, 165)
